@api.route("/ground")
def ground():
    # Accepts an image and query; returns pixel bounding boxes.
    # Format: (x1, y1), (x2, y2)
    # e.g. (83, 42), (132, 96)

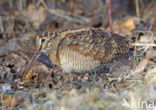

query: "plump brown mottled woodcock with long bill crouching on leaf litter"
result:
(23, 27), (135, 77)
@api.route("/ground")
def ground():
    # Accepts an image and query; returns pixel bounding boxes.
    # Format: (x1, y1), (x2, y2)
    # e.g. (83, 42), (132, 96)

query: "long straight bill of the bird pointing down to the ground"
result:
(21, 50), (41, 79)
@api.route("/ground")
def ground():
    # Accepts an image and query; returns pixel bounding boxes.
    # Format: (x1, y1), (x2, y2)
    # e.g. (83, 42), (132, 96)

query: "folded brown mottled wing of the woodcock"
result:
(59, 29), (117, 64)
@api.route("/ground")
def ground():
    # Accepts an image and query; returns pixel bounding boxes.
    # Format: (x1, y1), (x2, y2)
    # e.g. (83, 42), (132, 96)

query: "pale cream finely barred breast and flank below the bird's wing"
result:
(59, 48), (100, 73)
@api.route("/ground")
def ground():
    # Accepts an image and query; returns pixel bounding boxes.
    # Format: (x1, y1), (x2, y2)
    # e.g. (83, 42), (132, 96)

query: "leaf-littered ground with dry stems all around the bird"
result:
(0, 0), (156, 110)
